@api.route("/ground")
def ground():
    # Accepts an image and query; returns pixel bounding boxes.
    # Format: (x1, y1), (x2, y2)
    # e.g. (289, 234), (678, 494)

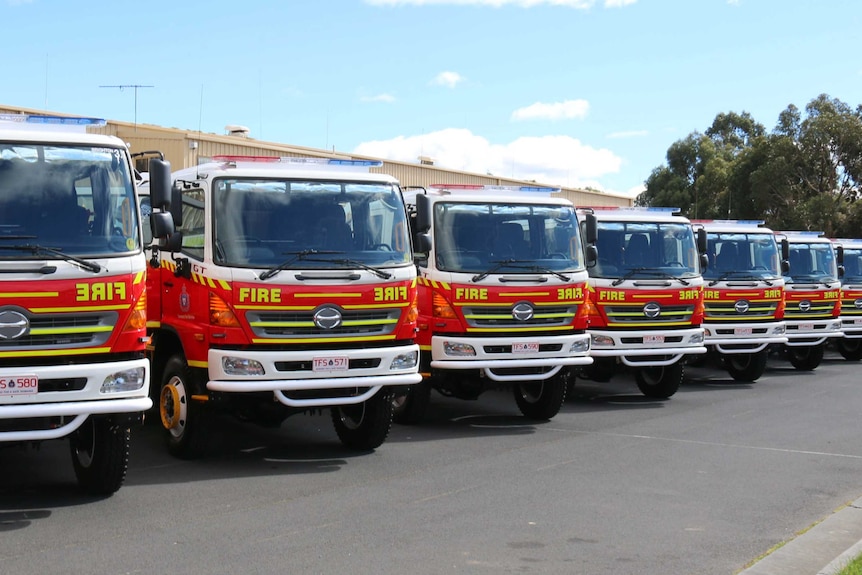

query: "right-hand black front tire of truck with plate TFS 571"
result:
(332, 388), (393, 451)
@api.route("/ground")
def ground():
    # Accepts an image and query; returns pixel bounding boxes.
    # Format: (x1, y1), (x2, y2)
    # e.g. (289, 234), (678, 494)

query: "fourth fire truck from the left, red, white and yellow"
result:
(578, 207), (707, 398)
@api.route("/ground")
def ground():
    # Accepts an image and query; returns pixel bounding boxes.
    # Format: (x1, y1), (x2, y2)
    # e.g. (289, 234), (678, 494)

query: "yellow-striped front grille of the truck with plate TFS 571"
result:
(245, 308), (401, 338)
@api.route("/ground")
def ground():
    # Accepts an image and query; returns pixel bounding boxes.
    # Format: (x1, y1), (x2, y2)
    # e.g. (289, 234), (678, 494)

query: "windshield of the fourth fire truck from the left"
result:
(590, 221), (700, 278)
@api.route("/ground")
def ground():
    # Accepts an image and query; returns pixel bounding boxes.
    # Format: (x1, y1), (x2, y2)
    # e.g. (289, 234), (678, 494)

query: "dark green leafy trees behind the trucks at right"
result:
(635, 94), (862, 237)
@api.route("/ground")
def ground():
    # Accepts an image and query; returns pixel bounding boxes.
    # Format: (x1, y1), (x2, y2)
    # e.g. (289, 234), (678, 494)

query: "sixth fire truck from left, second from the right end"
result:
(778, 231), (842, 371)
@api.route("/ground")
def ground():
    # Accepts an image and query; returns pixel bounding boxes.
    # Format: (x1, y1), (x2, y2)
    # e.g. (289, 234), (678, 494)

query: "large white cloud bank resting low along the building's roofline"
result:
(353, 128), (622, 189)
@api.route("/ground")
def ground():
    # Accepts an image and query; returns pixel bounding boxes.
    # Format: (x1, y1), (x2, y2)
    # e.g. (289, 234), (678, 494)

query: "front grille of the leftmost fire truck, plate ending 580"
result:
(0, 311), (119, 351)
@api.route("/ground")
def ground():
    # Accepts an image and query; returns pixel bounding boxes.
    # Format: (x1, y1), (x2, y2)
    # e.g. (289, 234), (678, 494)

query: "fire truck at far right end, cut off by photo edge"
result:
(833, 239), (862, 361)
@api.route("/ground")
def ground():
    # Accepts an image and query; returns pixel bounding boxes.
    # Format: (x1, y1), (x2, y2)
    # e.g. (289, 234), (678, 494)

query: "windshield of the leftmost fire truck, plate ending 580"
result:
(0, 142), (140, 260)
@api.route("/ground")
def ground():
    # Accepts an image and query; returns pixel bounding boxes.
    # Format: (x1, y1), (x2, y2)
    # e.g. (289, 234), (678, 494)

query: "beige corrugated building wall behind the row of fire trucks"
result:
(0, 105), (633, 206)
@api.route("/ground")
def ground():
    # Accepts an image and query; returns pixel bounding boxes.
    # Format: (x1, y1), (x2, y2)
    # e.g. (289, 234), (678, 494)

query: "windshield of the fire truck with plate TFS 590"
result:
(434, 202), (584, 273)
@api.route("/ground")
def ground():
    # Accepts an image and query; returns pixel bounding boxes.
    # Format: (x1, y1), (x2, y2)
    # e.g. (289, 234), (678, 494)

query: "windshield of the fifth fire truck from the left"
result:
(703, 233), (781, 281)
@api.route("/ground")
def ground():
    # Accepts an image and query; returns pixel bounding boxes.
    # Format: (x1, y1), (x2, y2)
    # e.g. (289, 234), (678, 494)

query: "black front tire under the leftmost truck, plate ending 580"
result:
(69, 416), (131, 495)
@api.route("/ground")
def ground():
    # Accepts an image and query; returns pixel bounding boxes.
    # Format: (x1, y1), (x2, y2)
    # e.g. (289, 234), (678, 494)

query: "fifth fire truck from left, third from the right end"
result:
(692, 220), (787, 382)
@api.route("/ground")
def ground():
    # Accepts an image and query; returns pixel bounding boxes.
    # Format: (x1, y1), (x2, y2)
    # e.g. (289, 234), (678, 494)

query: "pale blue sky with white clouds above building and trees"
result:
(0, 0), (862, 195)
